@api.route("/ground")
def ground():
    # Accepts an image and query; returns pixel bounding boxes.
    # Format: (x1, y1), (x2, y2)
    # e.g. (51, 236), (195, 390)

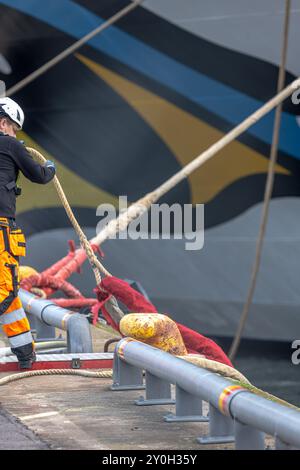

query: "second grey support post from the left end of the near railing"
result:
(135, 371), (175, 406)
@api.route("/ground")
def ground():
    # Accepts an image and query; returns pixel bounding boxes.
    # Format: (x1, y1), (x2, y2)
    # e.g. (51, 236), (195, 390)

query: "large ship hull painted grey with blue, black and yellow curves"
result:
(0, 0), (300, 341)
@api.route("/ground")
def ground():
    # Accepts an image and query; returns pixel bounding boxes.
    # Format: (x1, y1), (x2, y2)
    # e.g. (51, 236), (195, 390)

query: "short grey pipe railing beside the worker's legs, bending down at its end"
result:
(19, 289), (93, 353)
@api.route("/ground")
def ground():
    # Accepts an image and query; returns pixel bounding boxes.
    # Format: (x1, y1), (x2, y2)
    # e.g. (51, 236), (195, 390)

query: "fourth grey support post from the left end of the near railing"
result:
(197, 404), (234, 444)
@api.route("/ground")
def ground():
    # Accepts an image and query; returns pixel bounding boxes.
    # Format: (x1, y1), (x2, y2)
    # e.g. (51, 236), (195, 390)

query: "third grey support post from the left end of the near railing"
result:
(164, 384), (209, 423)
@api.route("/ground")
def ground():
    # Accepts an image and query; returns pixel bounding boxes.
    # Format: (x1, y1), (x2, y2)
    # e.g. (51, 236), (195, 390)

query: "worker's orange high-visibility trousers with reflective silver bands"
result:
(0, 217), (34, 361)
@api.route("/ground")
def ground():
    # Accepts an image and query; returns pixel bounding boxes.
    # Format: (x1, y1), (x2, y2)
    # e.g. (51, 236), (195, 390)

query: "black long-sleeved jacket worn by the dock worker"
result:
(0, 132), (55, 218)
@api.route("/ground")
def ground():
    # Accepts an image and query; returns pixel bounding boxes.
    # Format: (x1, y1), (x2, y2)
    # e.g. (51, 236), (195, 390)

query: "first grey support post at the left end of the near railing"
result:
(110, 352), (145, 392)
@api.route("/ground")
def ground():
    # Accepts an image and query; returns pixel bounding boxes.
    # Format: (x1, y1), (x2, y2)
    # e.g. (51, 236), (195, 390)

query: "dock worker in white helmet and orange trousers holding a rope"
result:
(0, 97), (55, 369)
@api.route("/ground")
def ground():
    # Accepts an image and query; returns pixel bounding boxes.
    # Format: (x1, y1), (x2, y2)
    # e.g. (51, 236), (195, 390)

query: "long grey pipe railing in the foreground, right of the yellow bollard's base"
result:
(112, 338), (300, 449)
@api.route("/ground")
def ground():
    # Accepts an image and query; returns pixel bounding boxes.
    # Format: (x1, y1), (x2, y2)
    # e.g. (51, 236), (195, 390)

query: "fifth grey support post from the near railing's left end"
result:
(234, 421), (265, 450)
